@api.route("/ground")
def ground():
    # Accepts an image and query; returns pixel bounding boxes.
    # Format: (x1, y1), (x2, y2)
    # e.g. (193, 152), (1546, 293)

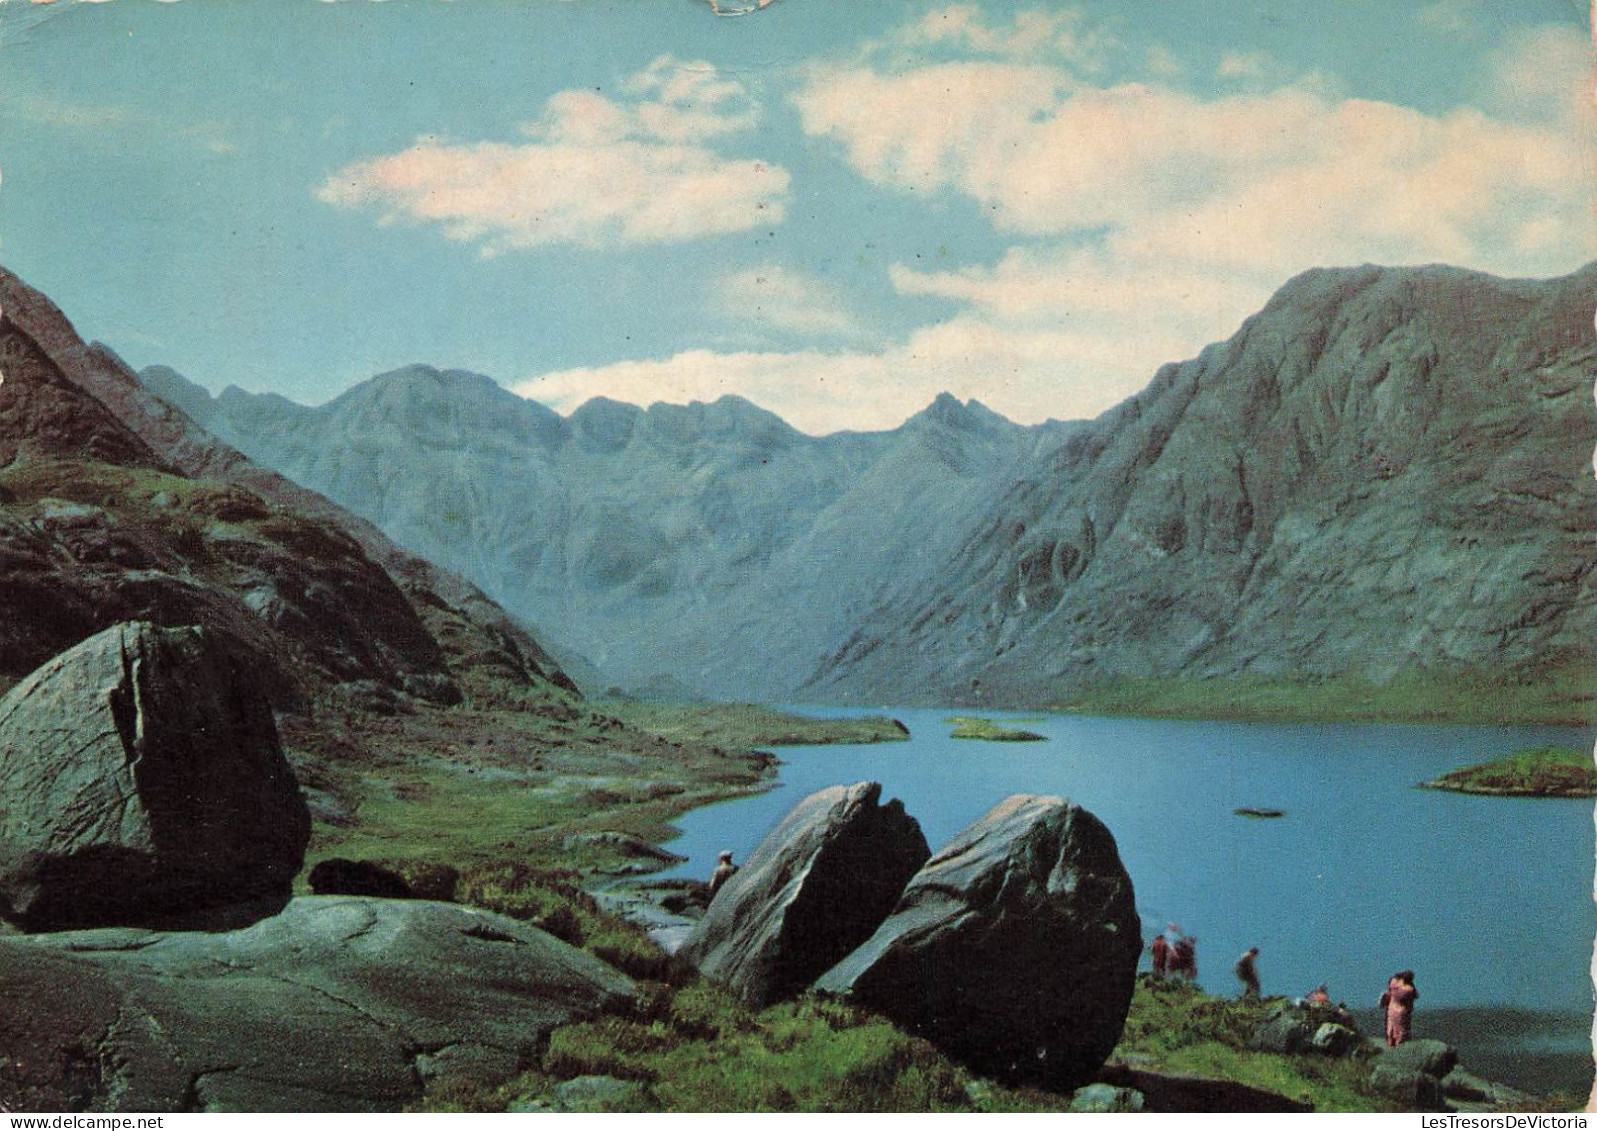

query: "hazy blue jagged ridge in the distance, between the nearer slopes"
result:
(162, 366), (1068, 700)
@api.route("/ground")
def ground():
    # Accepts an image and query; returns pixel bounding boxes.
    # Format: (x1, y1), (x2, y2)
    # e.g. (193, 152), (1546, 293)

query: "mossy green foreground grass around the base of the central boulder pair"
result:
(405, 872), (1526, 1112)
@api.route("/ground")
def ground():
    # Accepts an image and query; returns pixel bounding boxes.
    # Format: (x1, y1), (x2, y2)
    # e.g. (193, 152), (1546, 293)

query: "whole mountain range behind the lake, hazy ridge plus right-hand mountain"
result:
(142, 267), (1597, 704)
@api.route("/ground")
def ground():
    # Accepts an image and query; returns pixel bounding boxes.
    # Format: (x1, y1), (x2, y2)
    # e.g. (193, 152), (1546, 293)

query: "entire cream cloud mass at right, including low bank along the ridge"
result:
(542, 24), (1594, 433)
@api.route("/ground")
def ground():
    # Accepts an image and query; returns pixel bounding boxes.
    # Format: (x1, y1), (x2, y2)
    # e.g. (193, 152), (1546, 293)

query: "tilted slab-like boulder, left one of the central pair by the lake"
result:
(679, 781), (931, 1005)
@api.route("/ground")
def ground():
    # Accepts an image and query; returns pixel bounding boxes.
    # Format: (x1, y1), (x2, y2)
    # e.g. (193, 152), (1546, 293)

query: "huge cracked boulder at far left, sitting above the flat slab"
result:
(0, 621), (310, 930)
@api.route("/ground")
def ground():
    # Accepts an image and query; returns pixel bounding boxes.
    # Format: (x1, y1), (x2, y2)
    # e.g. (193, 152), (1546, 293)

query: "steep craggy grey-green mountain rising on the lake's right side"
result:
(806, 265), (1597, 703)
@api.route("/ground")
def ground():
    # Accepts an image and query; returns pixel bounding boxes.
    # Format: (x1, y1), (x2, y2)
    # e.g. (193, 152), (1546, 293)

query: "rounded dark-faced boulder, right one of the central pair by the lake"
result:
(816, 796), (1142, 1088)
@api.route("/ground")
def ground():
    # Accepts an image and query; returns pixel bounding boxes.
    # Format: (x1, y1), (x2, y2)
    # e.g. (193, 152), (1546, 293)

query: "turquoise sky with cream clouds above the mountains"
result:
(0, 0), (1597, 433)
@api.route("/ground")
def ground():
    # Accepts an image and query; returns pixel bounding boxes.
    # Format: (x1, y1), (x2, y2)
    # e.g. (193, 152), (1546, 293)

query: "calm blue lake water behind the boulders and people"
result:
(654, 708), (1597, 1083)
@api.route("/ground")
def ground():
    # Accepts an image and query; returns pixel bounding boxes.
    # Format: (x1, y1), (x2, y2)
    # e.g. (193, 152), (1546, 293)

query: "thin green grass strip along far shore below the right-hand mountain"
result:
(1057, 657), (1597, 727)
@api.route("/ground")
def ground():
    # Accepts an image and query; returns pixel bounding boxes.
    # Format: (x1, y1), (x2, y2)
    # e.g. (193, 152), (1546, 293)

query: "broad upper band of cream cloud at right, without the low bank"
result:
(795, 64), (1592, 280)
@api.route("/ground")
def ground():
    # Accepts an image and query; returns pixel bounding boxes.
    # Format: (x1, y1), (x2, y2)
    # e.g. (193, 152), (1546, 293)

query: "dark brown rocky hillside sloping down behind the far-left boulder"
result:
(0, 268), (573, 711)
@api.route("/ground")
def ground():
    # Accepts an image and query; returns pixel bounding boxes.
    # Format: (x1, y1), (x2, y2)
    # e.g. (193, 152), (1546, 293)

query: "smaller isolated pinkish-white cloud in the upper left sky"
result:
(316, 56), (789, 256)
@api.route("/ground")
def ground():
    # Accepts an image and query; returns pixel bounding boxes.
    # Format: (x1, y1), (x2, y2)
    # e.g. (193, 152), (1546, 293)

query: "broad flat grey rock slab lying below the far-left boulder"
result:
(0, 896), (637, 1112)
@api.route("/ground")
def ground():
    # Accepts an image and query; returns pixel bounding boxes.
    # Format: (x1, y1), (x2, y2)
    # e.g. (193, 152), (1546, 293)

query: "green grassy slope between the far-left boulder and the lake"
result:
(297, 703), (907, 888)
